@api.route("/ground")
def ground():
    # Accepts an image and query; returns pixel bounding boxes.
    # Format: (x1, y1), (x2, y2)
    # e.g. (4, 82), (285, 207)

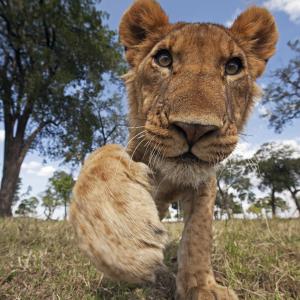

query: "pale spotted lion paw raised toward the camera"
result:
(70, 145), (167, 282)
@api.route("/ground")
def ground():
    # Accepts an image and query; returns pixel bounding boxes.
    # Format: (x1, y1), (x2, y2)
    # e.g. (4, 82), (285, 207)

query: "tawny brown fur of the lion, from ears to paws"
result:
(70, 0), (278, 300)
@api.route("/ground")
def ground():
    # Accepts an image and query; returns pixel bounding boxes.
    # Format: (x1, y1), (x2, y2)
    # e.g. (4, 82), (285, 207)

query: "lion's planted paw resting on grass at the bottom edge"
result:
(184, 285), (238, 300)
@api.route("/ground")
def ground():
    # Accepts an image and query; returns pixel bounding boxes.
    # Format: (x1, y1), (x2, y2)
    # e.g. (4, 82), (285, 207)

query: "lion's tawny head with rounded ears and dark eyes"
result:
(120, 0), (278, 185)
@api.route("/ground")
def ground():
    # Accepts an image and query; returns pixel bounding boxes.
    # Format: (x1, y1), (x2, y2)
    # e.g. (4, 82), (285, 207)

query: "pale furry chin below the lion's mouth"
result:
(153, 156), (215, 189)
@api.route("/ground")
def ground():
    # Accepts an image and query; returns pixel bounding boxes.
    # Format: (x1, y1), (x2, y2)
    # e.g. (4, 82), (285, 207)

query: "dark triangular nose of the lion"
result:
(173, 122), (218, 146)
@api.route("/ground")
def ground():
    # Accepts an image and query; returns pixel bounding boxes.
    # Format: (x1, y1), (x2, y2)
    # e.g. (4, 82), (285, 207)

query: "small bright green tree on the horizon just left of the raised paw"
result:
(44, 171), (75, 220)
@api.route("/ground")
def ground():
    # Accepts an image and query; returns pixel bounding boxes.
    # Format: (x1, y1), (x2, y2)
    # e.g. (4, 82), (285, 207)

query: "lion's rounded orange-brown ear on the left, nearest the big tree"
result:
(119, 0), (169, 65)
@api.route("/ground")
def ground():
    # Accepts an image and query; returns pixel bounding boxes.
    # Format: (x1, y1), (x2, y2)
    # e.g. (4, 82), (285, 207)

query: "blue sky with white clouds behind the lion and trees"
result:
(0, 0), (300, 214)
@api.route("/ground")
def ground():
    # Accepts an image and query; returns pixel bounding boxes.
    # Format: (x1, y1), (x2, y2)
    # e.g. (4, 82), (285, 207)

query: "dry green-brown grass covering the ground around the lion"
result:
(0, 218), (300, 300)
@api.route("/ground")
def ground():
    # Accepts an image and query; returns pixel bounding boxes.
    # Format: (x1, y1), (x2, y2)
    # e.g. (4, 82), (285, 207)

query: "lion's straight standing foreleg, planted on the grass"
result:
(176, 178), (237, 300)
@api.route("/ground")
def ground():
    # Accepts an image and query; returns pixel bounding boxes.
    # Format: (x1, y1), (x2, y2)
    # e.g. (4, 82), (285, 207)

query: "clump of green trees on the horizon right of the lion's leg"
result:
(216, 142), (300, 218)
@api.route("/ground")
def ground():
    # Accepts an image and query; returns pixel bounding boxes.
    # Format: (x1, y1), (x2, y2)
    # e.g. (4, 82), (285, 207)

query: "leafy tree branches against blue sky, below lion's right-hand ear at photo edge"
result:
(262, 40), (300, 132)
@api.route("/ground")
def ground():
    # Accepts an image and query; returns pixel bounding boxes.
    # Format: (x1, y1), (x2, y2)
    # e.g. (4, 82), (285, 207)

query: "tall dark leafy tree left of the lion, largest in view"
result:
(0, 0), (123, 216)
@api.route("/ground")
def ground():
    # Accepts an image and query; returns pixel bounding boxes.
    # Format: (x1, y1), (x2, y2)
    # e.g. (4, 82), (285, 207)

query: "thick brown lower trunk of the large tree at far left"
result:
(0, 141), (24, 217)
